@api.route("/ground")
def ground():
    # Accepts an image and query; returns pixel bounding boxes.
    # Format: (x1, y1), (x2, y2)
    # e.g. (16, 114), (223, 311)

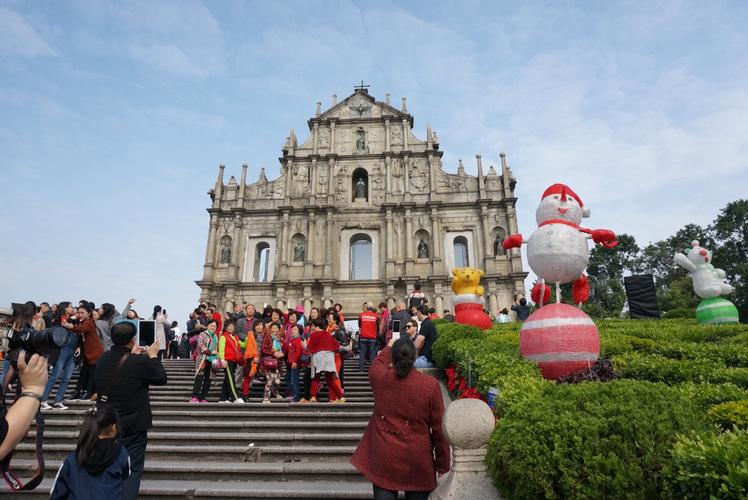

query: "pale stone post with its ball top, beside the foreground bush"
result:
(431, 399), (501, 500)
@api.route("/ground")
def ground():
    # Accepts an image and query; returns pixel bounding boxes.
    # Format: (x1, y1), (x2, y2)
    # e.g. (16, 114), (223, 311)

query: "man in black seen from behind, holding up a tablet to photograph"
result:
(96, 321), (166, 500)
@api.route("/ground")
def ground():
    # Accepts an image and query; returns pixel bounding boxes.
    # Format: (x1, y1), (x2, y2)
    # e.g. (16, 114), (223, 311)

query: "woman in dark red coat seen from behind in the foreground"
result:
(351, 338), (450, 500)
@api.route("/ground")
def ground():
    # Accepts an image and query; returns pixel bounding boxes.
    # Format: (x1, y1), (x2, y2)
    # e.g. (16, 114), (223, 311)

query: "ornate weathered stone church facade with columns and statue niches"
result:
(197, 89), (527, 313)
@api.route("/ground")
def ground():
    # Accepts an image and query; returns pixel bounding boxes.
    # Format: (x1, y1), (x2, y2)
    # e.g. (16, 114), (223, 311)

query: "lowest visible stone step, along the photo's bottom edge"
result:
(18, 478), (388, 500)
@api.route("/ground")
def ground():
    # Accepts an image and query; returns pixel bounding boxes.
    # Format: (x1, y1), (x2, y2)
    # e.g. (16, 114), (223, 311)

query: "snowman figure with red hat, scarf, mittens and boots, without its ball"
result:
(503, 184), (618, 306)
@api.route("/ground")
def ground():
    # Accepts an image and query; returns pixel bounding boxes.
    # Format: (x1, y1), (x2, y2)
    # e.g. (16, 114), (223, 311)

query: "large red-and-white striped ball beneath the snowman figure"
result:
(519, 304), (600, 379)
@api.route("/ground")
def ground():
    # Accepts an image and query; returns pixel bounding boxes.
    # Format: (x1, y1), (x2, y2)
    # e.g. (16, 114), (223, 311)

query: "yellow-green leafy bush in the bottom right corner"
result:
(663, 430), (748, 499)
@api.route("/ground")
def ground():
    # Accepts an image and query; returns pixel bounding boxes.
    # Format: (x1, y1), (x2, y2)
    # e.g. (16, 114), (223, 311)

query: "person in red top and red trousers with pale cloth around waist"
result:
(302, 318), (345, 403)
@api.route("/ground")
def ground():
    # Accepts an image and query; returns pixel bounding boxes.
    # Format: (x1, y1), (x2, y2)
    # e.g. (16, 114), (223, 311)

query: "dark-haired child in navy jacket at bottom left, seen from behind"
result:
(50, 405), (130, 500)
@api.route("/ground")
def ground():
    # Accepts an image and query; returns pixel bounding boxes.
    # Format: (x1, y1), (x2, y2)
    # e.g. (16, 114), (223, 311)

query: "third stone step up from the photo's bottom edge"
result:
(13, 444), (356, 463)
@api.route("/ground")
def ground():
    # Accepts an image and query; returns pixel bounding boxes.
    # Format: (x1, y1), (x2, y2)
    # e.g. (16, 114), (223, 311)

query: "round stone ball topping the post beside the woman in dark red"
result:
(444, 398), (496, 450)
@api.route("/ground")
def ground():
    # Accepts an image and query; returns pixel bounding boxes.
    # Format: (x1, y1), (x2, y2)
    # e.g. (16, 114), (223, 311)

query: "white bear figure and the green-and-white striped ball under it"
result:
(673, 240), (738, 324)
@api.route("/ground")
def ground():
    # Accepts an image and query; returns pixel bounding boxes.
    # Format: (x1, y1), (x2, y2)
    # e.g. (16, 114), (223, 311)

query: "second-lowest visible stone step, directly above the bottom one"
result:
(8, 459), (366, 482)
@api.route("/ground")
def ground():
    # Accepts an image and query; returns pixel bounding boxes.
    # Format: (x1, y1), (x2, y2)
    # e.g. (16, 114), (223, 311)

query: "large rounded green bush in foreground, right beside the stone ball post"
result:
(486, 380), (707, 499)
